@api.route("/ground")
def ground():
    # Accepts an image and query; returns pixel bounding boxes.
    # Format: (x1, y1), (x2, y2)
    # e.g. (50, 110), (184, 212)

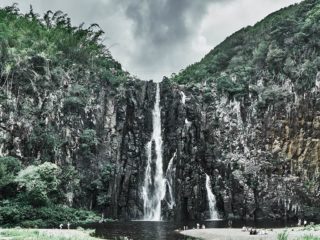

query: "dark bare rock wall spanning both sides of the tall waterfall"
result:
(0, 75), (320, 220)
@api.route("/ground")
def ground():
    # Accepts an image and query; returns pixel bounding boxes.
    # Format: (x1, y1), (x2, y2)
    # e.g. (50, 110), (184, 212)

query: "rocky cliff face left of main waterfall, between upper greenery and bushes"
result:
(0, 71), (159, 218)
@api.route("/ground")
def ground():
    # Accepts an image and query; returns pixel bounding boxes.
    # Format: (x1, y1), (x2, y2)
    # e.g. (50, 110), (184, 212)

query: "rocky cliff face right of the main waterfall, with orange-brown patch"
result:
(159, 80), (320, 219)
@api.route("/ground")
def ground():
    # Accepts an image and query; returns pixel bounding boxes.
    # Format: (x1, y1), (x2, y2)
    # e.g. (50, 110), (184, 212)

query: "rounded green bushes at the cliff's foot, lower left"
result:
(0, 157), (100, 228)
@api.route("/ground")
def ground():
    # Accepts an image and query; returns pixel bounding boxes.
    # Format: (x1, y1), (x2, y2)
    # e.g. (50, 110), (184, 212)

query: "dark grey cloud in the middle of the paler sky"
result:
(121, 0), (228, 77)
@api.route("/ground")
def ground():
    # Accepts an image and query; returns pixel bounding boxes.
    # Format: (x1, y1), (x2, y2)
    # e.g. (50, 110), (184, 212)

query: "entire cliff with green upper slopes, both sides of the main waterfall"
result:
(0, 0), (320, 223)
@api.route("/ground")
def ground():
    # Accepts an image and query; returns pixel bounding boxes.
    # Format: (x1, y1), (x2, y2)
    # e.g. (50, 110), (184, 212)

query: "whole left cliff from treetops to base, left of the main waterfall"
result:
(0, 5), (155, 221)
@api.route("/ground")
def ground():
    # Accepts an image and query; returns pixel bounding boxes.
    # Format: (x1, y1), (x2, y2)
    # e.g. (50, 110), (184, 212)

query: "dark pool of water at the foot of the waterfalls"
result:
(88, 220), (296, 240)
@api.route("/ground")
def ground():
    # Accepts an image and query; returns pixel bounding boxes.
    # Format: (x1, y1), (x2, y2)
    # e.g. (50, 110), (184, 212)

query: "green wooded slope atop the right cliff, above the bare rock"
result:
(172, 0), (320, 95)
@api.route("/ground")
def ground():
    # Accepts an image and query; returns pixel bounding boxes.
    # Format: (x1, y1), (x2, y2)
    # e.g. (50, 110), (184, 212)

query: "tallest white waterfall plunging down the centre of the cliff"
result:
(142, 83), (166, 221)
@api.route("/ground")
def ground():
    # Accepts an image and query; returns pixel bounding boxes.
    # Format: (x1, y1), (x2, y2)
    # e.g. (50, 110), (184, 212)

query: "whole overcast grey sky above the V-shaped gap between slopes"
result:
(0, 0), (301, 81)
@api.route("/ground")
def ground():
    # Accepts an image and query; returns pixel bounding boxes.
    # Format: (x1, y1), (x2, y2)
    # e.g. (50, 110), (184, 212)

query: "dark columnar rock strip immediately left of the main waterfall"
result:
(100, 82), (155, 219)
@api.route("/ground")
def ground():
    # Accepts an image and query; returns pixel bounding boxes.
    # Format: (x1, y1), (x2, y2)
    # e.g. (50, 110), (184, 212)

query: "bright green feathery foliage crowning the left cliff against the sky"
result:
(0, 5), (128, 89)
